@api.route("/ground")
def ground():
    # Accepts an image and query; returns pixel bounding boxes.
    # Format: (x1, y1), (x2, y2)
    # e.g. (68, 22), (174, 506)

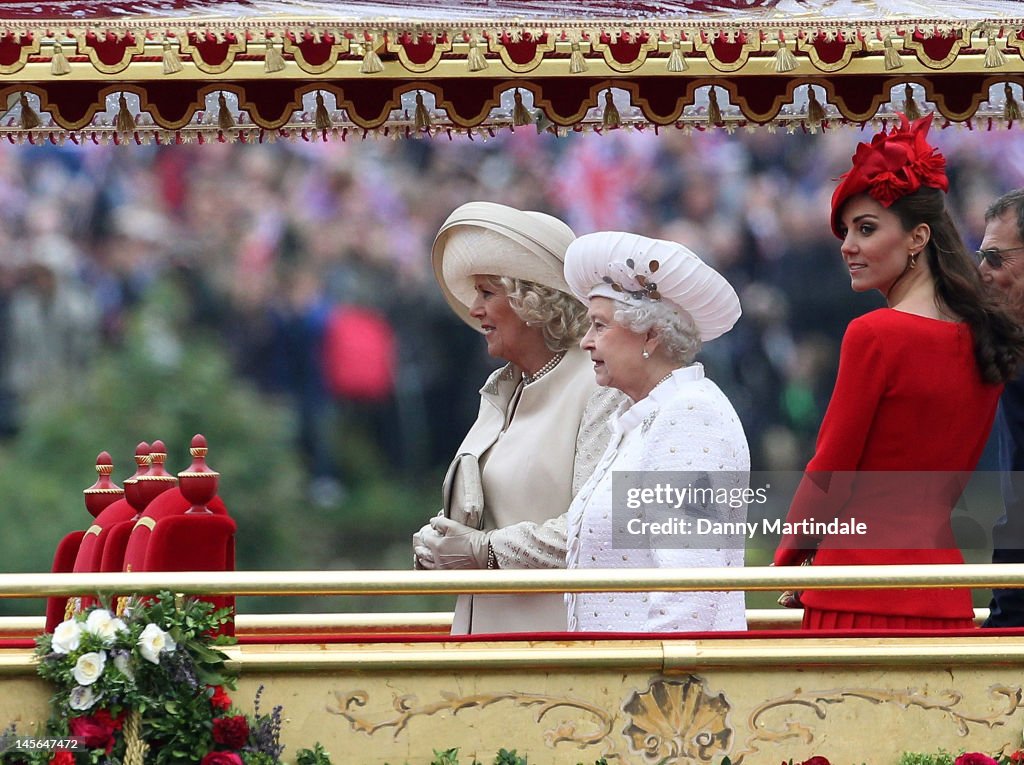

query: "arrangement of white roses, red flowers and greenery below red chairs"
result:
(0, 592), (330, 765)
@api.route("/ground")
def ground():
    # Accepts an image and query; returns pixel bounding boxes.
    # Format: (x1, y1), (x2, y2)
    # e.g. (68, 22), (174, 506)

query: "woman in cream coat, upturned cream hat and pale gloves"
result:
(413, 202), (618, 634)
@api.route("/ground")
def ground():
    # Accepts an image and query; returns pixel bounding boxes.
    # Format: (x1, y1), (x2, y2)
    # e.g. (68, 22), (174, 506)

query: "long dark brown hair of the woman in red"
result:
(890, 187), (1024, 383)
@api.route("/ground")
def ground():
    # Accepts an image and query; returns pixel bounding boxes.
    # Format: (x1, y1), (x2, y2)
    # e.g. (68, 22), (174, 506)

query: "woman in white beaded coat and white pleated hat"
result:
(565, 231), (750, 632)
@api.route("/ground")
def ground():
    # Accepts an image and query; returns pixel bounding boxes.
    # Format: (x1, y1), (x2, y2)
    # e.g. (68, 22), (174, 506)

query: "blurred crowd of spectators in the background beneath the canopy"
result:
(0, 127), (1024, 503)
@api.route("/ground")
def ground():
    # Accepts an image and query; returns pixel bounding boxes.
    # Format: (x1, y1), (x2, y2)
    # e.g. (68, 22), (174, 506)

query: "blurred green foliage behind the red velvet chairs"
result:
(0, 282), (451, 615)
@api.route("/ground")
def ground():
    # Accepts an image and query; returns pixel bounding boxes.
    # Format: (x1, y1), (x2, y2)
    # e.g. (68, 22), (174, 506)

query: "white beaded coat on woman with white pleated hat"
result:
(565, 364), (751, 632)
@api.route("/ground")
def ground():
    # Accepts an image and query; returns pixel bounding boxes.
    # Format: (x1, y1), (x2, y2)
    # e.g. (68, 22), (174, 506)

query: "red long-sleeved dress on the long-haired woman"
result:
(775, 308), (1002, 629)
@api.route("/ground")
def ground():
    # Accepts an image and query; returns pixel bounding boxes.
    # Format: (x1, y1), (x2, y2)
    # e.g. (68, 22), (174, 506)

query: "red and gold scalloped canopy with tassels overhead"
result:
(0, 0), (1024, 140)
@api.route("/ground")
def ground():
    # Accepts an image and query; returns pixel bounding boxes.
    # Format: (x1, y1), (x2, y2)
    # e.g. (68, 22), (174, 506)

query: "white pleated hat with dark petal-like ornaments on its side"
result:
(565, 231), (741, 341)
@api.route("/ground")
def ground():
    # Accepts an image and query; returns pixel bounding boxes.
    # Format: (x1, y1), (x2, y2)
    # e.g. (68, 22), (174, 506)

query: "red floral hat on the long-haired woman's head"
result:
(831, 114), (949, 239)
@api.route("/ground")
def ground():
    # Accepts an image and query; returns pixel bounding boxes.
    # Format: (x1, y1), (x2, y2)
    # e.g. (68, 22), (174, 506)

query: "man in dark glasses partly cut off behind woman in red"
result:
(976, 188), (1024, 627)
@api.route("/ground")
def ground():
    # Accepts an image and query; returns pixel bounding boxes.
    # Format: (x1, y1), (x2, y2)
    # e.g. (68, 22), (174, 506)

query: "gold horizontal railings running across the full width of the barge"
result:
(0, 564), (1024, 677)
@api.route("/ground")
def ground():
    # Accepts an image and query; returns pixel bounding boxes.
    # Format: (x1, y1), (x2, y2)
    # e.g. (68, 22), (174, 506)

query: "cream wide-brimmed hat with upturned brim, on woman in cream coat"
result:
(430, 202), (575, 330)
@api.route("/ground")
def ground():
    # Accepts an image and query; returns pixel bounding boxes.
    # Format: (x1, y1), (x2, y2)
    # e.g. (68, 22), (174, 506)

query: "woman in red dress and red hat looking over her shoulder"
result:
(775, 115), (1024, 629)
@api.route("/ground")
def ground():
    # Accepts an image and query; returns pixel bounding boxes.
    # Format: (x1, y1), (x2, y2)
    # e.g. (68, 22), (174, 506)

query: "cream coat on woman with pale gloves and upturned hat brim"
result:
(442, 348), (622, 635)
